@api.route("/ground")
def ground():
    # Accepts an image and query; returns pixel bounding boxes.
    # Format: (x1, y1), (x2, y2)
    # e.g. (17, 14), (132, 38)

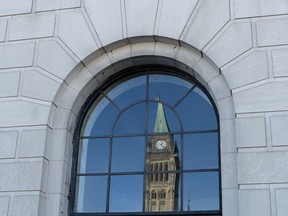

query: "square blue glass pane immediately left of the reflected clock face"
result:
(112, 137), (145, 172)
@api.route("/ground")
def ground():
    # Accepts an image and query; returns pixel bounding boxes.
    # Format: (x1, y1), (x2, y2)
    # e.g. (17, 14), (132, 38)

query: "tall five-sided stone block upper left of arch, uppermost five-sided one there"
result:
(58, 10), (98, 60)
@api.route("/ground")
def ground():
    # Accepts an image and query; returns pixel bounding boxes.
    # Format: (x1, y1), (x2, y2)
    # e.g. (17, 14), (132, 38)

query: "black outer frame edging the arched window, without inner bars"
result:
(68, 64), (222, 216)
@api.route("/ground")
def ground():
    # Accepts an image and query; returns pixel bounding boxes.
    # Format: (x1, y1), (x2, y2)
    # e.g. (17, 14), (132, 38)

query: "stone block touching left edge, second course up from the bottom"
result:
(0, 160), (43, 191)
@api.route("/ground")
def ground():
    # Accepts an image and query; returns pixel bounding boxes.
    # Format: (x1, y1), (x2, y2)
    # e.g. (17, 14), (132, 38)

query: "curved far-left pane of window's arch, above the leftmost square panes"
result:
(81, 97), (119, 136)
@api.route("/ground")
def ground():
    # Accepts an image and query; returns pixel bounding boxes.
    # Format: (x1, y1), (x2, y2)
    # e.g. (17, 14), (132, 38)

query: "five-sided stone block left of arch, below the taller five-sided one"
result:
(37, 40), (77, 79)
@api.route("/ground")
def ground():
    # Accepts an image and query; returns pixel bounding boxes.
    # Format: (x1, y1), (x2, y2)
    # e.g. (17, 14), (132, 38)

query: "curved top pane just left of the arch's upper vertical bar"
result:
(107, 76), (146, 108)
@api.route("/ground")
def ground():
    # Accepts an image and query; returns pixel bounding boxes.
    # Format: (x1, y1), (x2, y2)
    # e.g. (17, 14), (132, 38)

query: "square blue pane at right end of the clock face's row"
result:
(183, 133), (219, 169)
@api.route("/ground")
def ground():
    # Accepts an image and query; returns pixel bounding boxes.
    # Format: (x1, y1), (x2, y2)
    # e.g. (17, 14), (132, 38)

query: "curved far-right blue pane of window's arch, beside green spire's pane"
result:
(176, 88), (217, 131)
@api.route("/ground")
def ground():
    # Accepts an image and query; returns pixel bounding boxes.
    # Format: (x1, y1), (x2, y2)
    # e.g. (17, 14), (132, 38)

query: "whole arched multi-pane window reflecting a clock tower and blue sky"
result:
(70, 67), (221, 216)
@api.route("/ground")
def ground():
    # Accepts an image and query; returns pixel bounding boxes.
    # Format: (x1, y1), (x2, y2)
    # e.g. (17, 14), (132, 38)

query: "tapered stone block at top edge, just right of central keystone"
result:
(155, 0), (198, 39)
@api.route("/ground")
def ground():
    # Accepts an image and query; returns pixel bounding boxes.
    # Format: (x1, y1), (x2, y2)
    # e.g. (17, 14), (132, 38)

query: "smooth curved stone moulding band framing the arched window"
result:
(46, 37), (238, 215)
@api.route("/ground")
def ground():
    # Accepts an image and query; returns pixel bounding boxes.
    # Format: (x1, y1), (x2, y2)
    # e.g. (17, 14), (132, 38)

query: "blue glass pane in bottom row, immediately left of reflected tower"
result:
(109, 175), (143, 212)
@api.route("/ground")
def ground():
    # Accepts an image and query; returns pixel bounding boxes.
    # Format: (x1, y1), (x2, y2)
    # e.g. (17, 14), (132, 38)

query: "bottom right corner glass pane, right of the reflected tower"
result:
(183, 172), (220, 211)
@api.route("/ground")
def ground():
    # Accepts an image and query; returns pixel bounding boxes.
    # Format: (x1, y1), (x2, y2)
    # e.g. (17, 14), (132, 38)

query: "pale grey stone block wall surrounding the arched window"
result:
(0, 0), (288, 216)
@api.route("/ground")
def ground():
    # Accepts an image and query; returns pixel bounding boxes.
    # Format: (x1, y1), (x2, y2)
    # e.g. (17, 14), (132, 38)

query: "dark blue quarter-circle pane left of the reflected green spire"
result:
(114, 103), (145, 134)
